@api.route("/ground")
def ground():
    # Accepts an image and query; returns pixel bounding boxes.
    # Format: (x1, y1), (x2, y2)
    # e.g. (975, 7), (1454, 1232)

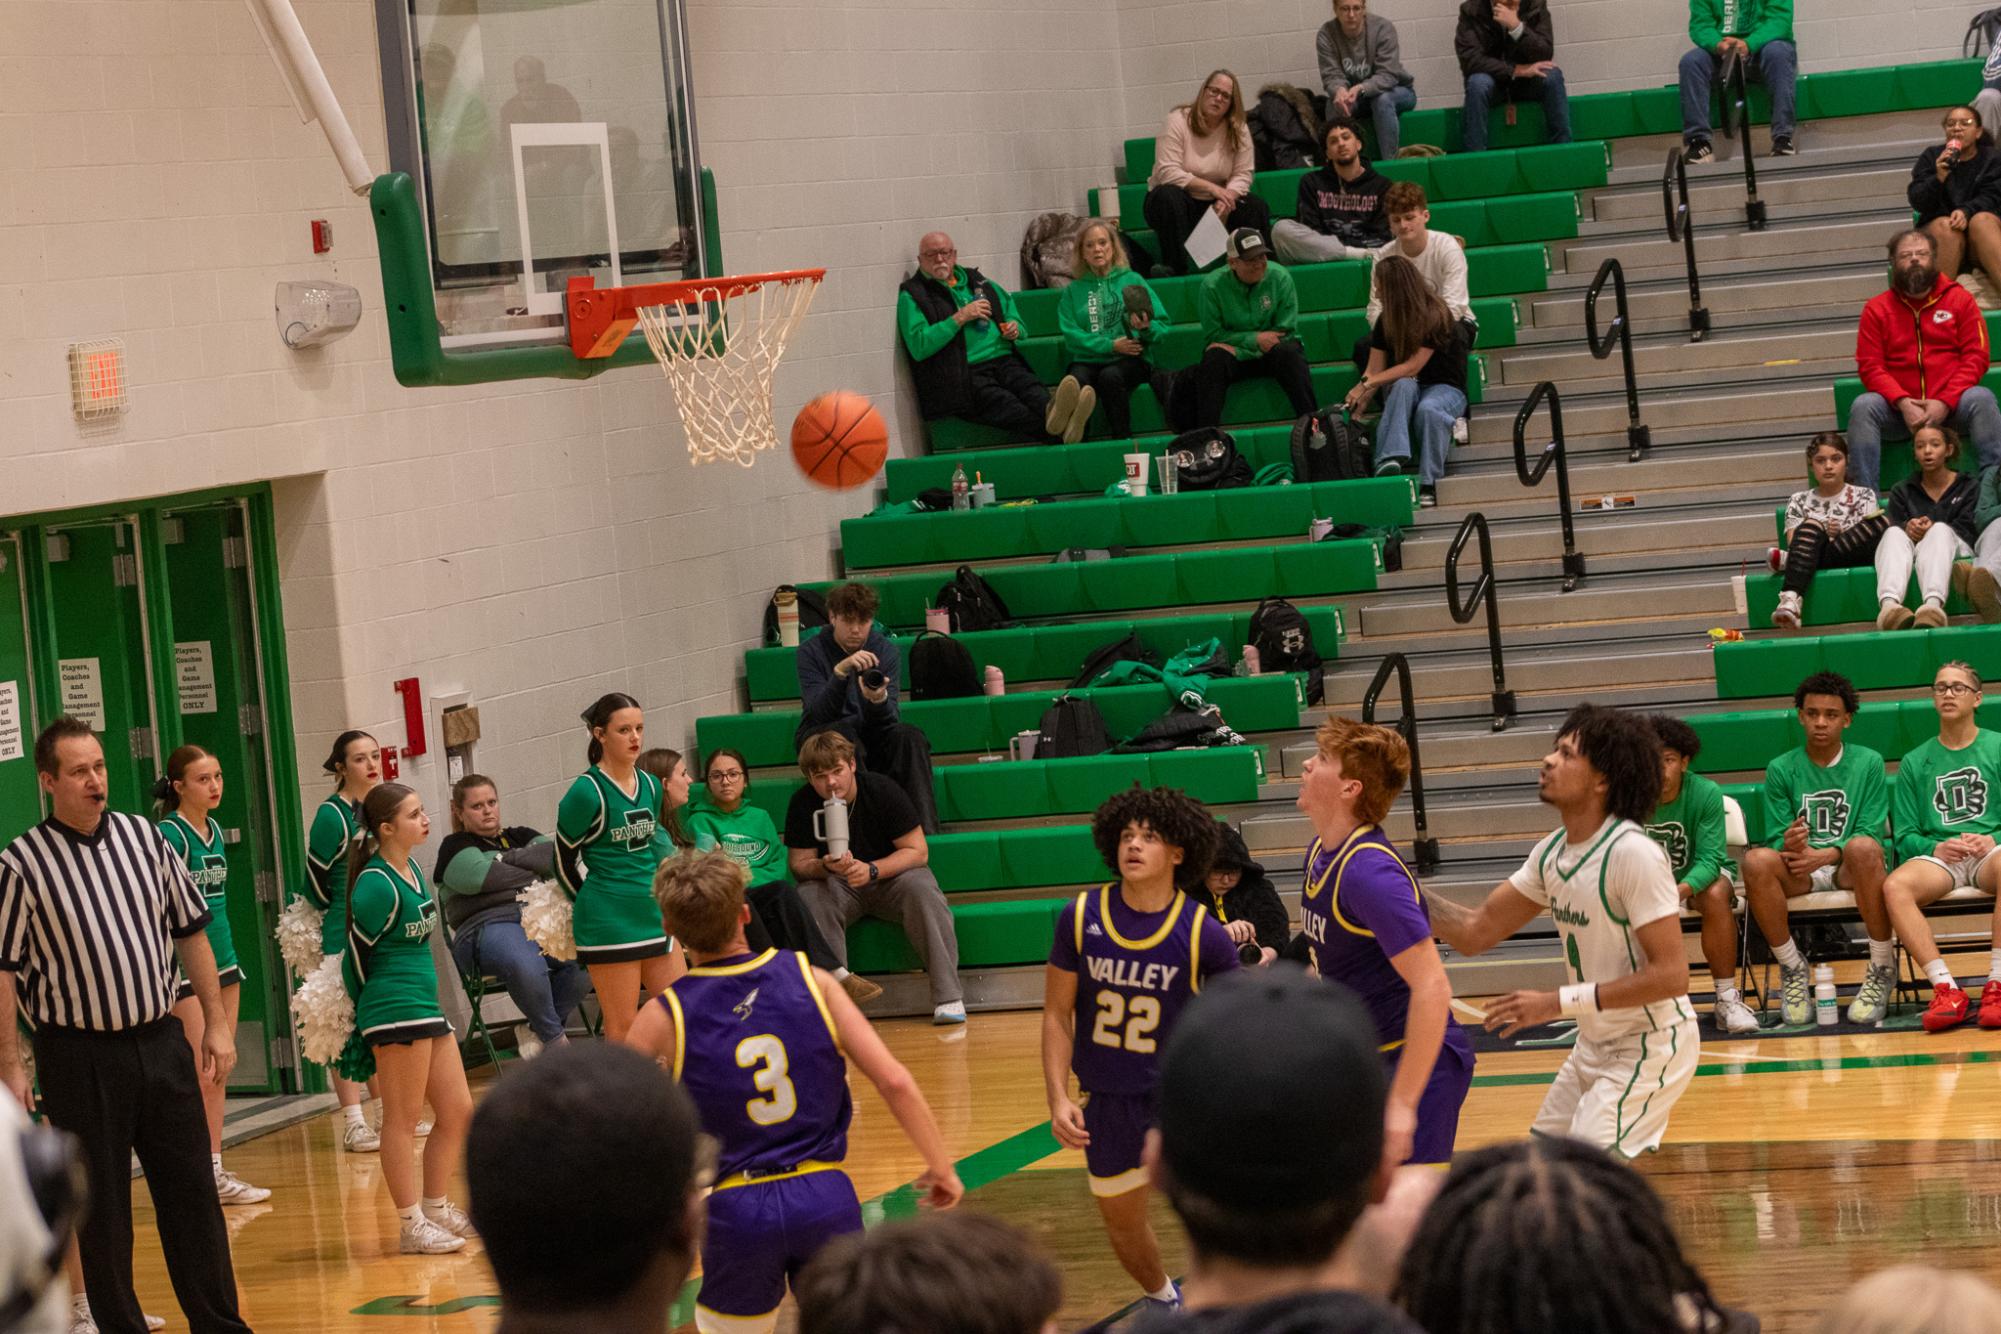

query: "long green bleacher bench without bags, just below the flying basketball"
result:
(840, 468), (1413, 572)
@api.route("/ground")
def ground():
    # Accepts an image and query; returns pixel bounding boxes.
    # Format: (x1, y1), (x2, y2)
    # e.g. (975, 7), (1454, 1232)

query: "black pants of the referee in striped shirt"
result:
(34, 1016), (250, 1334)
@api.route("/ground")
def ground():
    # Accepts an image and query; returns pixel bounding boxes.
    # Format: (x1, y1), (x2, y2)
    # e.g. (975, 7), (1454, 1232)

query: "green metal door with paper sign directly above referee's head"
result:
(42, 516), (158, 814)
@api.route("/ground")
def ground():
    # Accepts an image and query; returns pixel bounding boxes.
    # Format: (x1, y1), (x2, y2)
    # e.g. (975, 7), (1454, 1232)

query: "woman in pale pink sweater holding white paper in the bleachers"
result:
(1147, 70), (1271, 274)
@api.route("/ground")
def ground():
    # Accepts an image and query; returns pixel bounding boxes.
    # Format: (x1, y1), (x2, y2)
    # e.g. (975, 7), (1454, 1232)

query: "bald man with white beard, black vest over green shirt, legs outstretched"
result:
(896, 232), (1097, 444)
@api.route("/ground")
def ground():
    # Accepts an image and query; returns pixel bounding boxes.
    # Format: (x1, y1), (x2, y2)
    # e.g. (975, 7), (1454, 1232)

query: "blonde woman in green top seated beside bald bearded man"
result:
(1057, 218), (1167, 440)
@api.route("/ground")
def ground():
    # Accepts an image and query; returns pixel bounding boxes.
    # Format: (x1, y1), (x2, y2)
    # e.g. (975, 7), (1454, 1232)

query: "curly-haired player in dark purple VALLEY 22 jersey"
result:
(1043, 786), (1237, 1306)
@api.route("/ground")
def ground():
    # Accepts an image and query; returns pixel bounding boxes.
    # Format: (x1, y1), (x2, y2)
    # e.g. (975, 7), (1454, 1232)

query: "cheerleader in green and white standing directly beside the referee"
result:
(152, 746), (270, 1204)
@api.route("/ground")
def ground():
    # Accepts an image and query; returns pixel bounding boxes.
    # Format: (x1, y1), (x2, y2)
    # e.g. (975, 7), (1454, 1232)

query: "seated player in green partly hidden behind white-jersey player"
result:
(1647, 714), (1757, 1032)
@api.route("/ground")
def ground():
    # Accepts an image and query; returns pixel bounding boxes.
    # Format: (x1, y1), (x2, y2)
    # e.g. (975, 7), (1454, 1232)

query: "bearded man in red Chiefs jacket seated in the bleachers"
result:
(1849, 230), (2001, 488)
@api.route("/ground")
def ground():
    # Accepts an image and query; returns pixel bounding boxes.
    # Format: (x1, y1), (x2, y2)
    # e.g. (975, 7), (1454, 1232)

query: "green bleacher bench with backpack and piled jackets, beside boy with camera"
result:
(694, 672), (1305, 768)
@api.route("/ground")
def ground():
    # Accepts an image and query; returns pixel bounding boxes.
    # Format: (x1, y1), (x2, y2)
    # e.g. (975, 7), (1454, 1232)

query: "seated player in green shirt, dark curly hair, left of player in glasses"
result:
(1745, 672), (1897, 1024)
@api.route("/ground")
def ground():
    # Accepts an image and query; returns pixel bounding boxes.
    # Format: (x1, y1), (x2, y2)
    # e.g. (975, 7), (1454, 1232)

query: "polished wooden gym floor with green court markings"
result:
(113, 1012), (2001, 1334)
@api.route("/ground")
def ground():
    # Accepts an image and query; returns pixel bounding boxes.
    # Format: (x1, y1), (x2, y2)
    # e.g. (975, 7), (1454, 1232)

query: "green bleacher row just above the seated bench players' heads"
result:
(1715, 626), (2001, 712)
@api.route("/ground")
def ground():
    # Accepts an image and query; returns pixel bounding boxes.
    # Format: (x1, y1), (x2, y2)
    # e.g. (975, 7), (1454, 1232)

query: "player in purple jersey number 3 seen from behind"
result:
(624, 852), (964, 1334)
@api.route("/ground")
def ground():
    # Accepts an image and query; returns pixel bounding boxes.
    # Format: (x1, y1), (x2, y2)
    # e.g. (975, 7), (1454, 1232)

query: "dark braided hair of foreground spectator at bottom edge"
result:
(1395, 1138), (1723, 1334)
